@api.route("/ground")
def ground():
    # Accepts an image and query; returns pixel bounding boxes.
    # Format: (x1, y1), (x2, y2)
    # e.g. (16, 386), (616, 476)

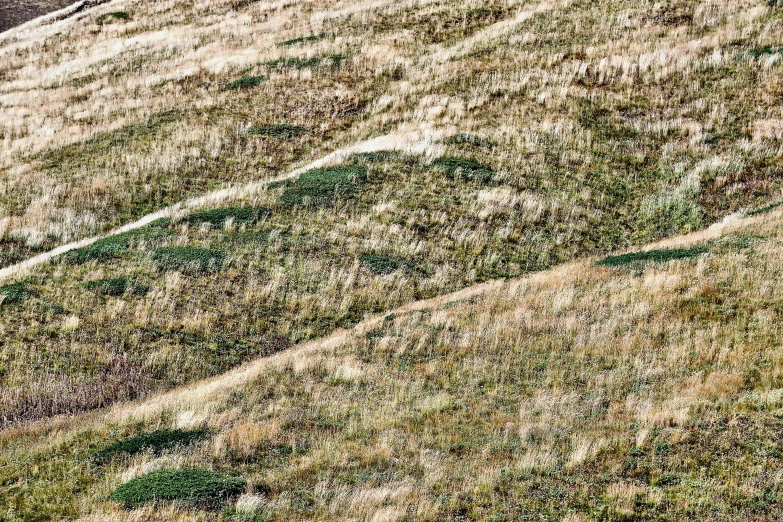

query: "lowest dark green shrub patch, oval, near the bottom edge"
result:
(109, 468), (247, 509)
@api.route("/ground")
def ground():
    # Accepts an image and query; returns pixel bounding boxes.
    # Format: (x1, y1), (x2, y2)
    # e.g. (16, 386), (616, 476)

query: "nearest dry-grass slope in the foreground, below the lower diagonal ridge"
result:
(0, 202), (783, 521)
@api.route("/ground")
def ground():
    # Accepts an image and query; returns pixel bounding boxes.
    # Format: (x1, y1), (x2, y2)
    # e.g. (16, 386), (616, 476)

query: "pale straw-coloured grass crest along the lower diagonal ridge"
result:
(110, 205), (772, 422)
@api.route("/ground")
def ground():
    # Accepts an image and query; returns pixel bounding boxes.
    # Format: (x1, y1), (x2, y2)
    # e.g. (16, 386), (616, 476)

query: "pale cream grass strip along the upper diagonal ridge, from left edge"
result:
(0, 130), (440, 283)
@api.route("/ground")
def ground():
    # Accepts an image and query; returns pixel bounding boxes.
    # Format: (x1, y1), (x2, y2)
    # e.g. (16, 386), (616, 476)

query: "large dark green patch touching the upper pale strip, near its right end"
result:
(279, 166), (367, 206)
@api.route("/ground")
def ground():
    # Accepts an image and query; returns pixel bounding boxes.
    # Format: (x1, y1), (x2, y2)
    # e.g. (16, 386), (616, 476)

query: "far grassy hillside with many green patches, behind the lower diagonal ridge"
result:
(0, 1), (783, 425)
